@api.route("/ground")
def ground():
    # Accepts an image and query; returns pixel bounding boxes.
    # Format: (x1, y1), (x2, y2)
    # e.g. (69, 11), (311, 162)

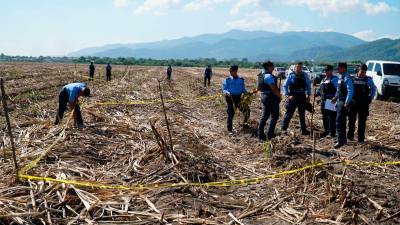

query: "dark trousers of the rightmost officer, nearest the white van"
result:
(347, 102), (369, 142)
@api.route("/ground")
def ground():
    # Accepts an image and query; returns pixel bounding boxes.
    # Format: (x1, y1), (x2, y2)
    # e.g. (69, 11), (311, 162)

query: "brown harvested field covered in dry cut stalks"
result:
(0, 64), (400, 224)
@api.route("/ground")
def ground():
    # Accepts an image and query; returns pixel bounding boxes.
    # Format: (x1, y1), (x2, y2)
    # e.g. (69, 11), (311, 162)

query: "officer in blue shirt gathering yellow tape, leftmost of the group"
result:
(223, 65), (250, 132)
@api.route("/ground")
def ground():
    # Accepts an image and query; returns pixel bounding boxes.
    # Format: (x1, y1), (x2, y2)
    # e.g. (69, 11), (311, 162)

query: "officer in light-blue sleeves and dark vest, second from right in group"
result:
(332, 62), (353, 148)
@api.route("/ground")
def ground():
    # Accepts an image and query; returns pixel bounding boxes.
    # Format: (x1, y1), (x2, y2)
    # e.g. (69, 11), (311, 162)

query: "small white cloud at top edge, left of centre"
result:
(135, 0), (180, 16)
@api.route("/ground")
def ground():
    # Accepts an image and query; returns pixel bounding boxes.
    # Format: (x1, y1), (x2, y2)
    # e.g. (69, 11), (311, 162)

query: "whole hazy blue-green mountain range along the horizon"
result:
(69, 30), (400, 61)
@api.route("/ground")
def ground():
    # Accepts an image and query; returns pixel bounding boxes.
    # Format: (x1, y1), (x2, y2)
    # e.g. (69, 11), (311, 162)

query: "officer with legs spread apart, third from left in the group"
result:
(282, 62), (311, 135)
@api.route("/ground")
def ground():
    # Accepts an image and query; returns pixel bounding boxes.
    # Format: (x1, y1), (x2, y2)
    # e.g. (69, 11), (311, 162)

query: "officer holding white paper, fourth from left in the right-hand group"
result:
(317, 65), (339, 137)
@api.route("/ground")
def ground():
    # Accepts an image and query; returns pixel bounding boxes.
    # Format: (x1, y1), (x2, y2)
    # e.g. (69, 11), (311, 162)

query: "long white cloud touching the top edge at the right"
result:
(285, 0), (396, 16)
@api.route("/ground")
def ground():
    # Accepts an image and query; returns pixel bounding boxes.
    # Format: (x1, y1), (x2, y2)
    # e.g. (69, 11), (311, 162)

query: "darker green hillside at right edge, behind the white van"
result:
(321, 38), (400, 61)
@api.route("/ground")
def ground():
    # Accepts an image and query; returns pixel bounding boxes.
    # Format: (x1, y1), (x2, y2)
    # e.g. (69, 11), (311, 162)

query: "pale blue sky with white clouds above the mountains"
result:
(0, 0), (400, 56)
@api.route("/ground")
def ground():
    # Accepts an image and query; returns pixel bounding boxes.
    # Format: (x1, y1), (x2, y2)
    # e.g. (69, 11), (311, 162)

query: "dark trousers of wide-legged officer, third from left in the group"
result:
(282, 93), (307, 132)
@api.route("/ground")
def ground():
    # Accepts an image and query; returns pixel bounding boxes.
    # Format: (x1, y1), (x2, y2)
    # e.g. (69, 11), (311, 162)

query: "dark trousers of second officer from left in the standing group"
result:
(258, 94), (279, 139)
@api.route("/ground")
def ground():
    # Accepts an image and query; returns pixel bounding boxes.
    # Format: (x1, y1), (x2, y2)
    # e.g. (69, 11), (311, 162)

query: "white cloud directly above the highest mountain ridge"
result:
(228, 11), (291, 32)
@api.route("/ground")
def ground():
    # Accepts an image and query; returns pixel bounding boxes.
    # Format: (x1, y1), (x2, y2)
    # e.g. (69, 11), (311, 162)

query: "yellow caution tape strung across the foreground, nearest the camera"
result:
(20, 161), (400, 190)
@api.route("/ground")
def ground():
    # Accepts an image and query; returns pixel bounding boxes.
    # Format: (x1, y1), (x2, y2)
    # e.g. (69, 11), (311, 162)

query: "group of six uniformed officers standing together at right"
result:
(223, 61), (376, 148)
